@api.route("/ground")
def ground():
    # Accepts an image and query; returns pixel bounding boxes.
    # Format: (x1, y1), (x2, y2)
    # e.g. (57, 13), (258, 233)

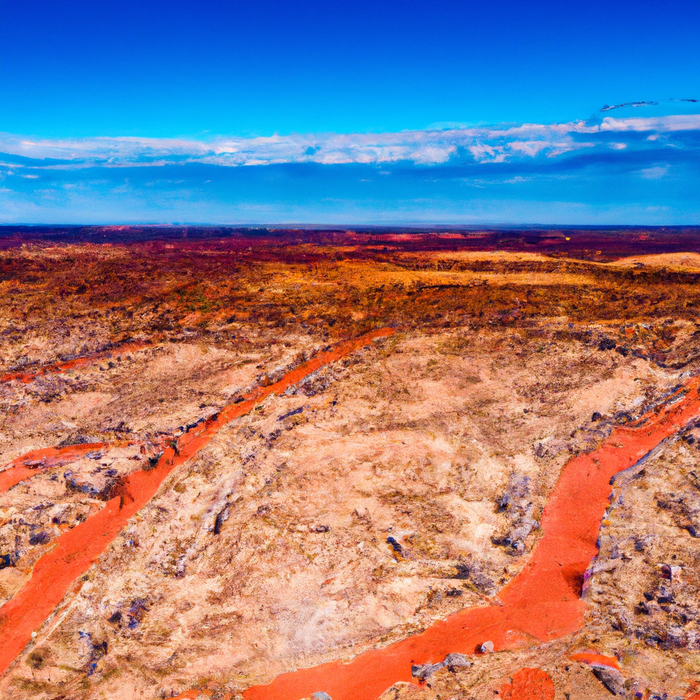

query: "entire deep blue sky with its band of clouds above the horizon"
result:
(0, 0), (700, 224)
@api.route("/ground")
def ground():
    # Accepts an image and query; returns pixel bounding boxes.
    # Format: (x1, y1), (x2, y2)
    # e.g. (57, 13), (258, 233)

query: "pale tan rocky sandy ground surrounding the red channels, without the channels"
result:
(0, 241), (700, 700)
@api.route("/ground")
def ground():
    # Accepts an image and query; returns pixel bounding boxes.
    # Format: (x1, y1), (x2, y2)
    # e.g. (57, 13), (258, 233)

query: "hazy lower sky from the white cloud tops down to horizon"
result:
(0, 103), (700, 224)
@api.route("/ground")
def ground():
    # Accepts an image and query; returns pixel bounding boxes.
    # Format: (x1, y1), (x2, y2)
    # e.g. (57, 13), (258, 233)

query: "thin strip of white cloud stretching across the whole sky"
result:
(0, 114), (700, 169)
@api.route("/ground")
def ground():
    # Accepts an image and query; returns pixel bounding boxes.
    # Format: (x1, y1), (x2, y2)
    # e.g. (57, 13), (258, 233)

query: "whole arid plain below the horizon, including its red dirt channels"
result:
(0, 228), (700, 700)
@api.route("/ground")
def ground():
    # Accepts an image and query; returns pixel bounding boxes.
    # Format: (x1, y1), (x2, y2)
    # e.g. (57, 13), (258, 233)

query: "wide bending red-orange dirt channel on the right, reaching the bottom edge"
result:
(243, 379), (700, 700)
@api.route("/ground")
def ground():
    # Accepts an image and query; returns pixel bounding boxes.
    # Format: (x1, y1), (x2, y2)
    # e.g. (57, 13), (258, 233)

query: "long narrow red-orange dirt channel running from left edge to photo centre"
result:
(0, 328), (394, 673)
